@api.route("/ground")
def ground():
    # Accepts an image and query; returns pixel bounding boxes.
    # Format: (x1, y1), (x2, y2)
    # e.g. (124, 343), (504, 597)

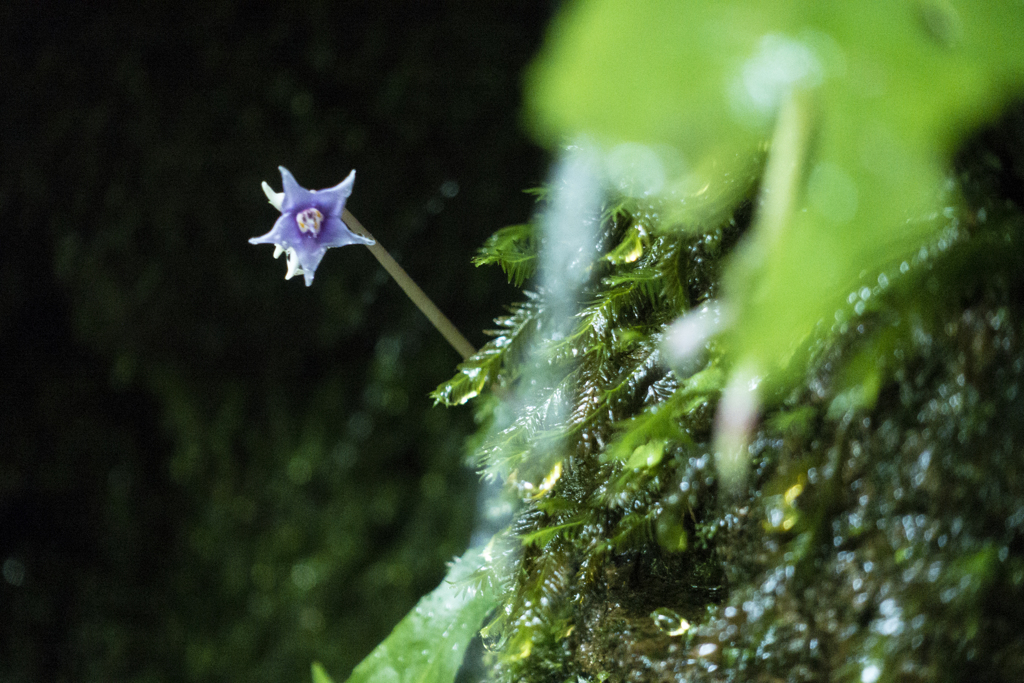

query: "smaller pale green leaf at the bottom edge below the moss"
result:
(327, 550), (498, 683)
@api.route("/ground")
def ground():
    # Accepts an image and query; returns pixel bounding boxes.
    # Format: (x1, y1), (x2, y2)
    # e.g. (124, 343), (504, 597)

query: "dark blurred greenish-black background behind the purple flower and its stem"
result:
(0, 0), (551, 683)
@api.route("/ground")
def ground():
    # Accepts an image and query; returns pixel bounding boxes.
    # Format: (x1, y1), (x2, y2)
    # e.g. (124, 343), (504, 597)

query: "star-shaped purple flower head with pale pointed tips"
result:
(249, 166), (374, 287)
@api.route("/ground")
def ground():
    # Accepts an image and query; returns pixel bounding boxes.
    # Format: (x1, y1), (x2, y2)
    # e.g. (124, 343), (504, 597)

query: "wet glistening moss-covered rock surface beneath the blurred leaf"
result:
(436, 102), (1024, 683)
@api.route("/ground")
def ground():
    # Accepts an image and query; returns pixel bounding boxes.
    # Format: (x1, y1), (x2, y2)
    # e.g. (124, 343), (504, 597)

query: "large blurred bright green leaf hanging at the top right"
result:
(527, 0), (1024, 393)
